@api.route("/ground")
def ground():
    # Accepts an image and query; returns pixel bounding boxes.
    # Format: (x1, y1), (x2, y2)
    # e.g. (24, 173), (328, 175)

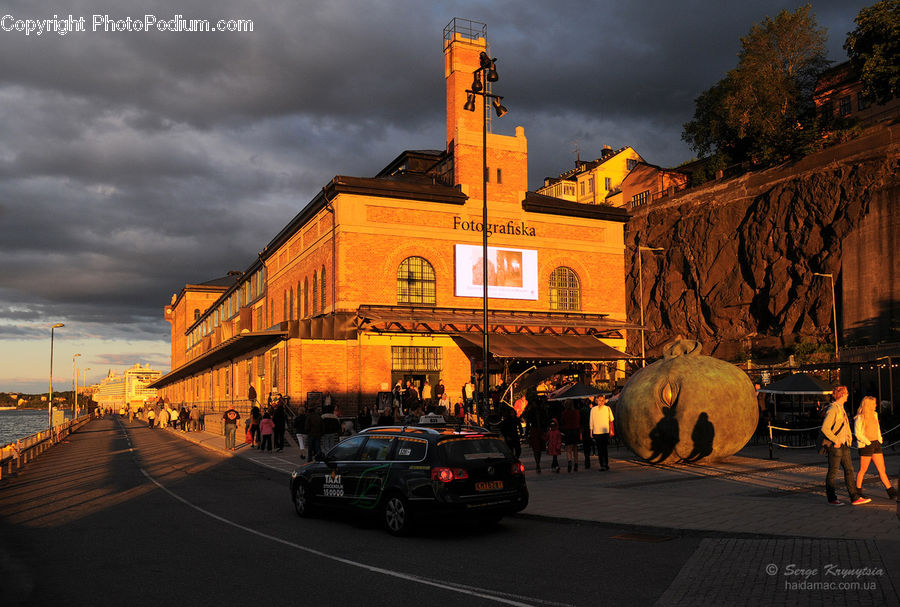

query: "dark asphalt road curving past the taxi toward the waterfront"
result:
(0, 419), (702, 607)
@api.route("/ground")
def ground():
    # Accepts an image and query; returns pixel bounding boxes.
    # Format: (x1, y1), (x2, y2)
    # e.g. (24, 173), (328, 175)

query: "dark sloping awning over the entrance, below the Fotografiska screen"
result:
(455, 333), (631, 362)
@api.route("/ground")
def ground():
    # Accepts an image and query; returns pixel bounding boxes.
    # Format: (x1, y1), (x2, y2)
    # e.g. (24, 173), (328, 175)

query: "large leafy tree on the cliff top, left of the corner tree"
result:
(682, 5), (828, 170)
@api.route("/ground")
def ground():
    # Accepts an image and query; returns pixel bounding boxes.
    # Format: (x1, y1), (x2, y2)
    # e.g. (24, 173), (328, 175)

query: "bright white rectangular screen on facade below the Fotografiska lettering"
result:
(456, 244), (538, 299)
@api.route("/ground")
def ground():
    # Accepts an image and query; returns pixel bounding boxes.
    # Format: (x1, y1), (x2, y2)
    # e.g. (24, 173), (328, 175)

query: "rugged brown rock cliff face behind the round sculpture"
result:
(625, 125), (900, 358)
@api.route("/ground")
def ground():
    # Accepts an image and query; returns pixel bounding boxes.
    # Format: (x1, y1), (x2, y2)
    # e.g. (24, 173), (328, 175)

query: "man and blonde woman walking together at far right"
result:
(822, 386), (897, 506)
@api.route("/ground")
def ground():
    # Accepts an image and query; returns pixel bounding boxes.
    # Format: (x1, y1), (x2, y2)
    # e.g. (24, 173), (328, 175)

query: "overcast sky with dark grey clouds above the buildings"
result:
(0, 0), (872, 392)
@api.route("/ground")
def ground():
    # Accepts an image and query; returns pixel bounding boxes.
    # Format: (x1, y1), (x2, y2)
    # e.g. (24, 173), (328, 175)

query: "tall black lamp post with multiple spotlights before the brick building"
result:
(463, 51), (508, 417)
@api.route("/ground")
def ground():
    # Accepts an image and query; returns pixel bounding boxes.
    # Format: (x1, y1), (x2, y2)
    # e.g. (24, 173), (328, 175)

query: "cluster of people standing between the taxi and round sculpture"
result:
(516, 396), (615, 474)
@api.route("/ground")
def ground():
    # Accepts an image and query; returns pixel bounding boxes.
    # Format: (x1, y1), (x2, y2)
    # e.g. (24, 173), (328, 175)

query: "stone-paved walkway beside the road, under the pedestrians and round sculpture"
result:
(158, 432), (900, 606)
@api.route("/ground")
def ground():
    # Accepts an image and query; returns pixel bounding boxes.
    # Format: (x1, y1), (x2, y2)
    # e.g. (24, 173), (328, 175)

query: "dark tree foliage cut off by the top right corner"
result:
(844, 0), (900, 104)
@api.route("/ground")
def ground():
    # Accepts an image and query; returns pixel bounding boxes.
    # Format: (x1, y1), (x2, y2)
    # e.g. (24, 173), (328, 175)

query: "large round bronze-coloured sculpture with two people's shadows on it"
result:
(616, 339), (759, 463)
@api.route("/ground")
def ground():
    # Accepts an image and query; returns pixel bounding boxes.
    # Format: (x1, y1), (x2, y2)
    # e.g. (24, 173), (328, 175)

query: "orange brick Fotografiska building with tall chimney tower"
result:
(155, 19), (633, 414)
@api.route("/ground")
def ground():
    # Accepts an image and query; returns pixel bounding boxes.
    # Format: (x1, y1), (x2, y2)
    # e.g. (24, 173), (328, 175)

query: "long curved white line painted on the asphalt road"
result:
(140, 468), (568, 607)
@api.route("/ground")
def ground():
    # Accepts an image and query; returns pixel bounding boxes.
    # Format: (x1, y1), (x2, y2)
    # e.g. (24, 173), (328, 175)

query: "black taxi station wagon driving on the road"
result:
(290, 425), (528, 535)
